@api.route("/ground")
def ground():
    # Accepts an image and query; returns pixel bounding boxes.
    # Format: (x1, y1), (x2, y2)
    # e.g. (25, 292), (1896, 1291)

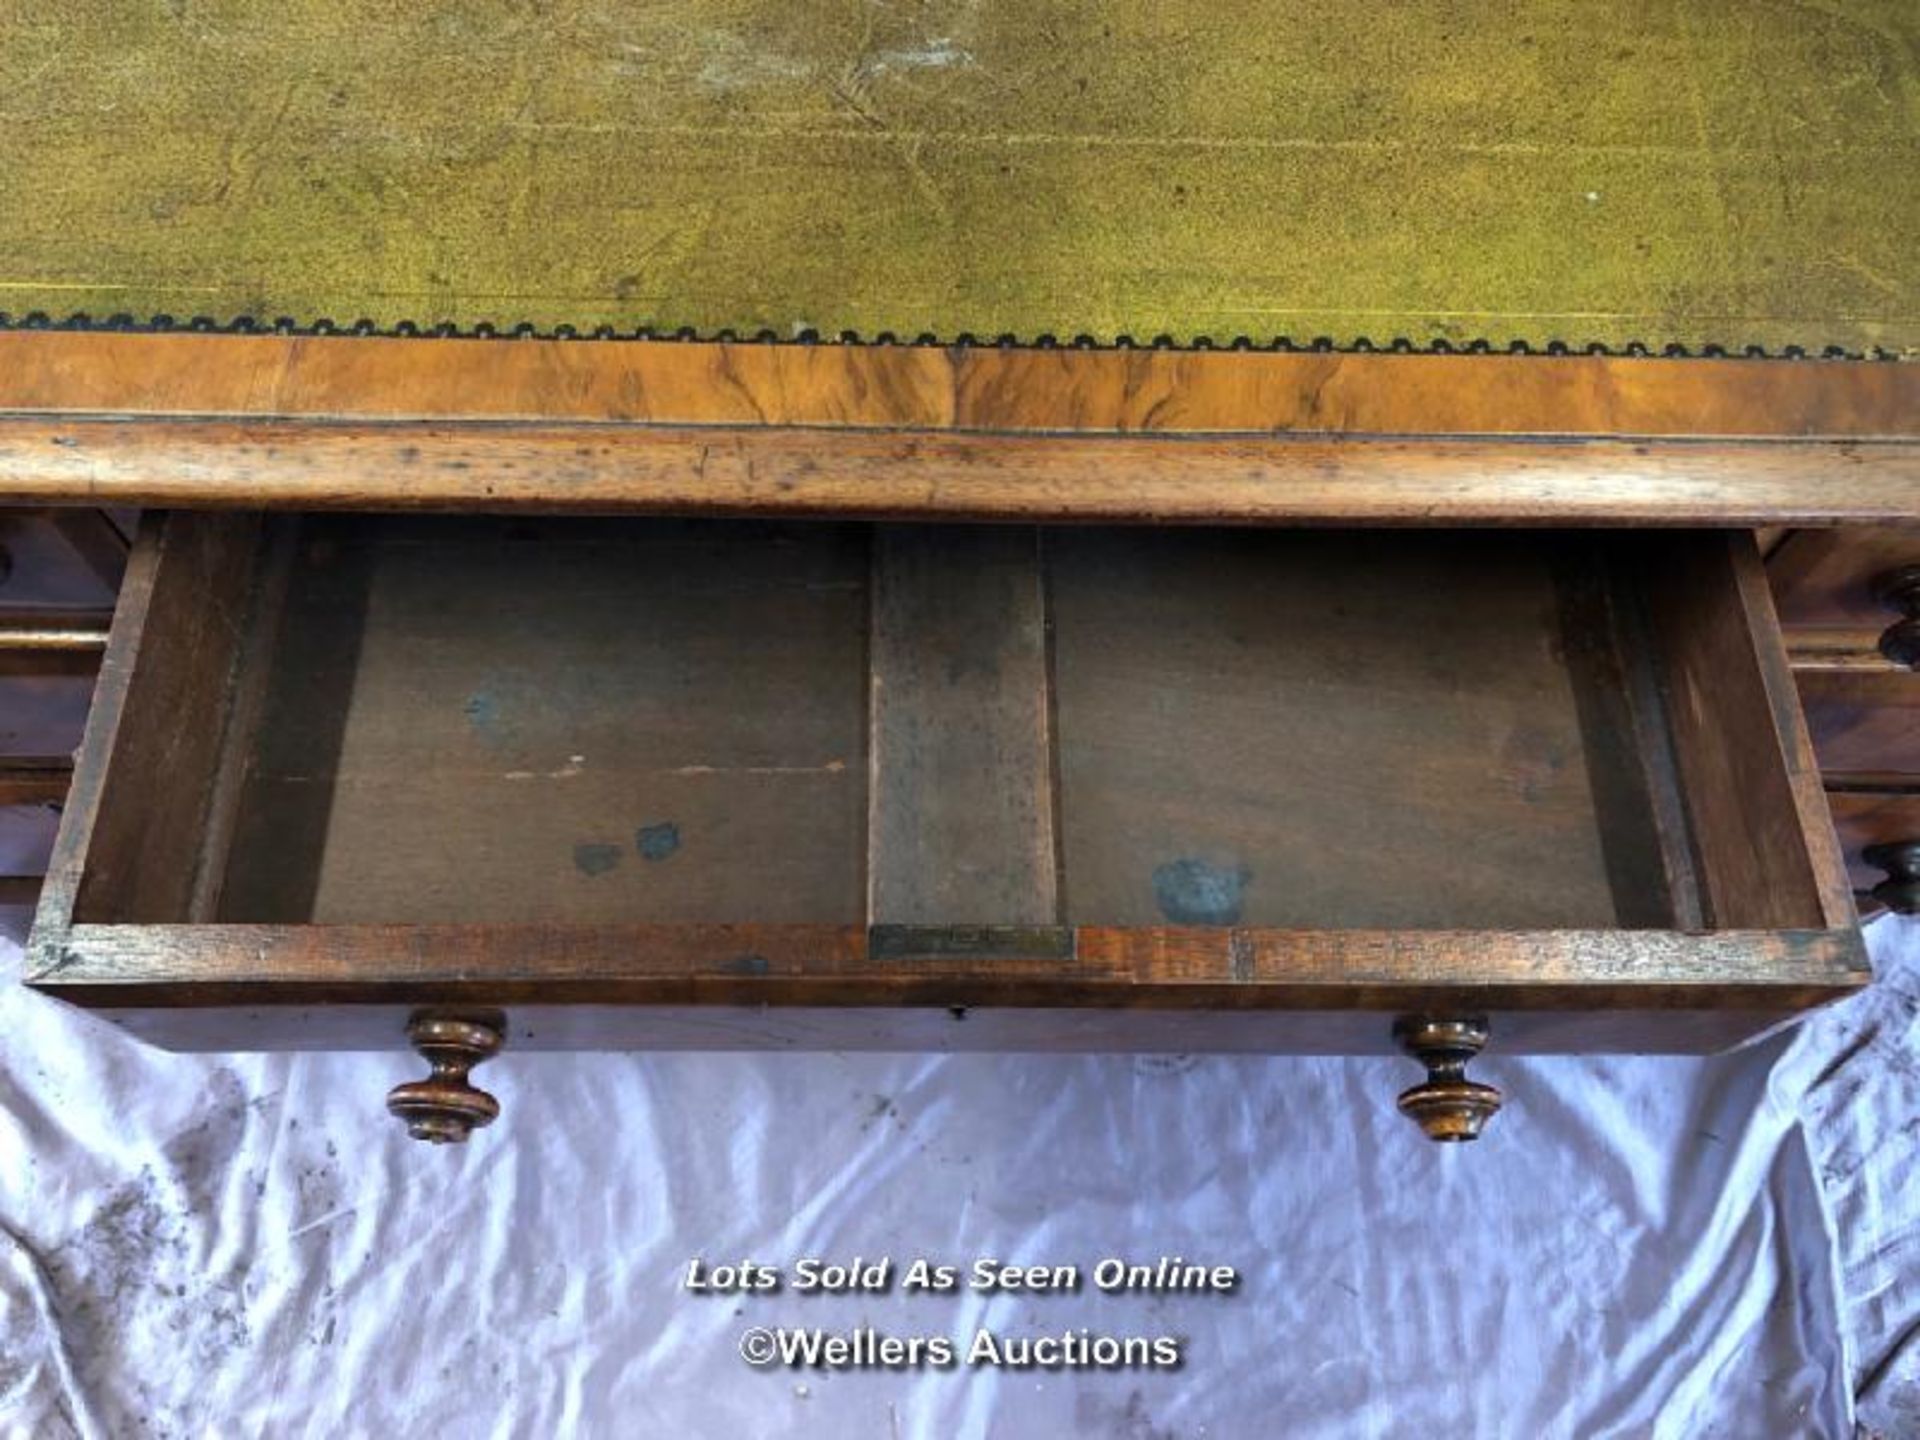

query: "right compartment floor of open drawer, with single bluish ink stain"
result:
(1046, 528), (1672, 929)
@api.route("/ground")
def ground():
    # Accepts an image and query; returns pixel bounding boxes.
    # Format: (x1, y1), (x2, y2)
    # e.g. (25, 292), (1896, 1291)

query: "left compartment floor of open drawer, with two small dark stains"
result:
(217, 516), (866, 924)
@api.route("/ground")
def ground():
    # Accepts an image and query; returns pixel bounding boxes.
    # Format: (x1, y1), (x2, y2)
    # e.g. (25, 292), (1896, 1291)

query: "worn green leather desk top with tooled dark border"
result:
(0, 0), (1920, 357)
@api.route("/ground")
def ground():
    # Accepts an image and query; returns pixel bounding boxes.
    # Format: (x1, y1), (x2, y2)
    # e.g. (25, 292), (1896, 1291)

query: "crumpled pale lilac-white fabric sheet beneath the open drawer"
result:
(0, 918), (1920, 1440)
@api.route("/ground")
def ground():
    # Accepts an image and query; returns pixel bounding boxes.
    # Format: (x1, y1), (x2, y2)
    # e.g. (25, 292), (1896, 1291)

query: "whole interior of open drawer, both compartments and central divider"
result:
(56, 515), (1824, 931)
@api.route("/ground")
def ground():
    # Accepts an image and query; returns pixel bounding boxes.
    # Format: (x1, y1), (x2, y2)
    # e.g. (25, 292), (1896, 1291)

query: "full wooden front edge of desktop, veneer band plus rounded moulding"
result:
(0, 332), (1920, 526)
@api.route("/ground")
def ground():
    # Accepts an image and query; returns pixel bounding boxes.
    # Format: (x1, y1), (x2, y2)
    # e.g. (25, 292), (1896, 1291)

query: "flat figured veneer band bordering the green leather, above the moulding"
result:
(0, 330), (1920, 440)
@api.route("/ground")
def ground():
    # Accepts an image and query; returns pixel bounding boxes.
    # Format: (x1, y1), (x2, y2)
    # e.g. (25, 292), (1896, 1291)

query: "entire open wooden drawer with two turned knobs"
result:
(31, 513), (1866, 1139)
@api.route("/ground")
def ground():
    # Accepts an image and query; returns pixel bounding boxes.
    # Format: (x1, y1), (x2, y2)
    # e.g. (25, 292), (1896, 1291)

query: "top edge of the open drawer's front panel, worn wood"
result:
(29, 925), (1868, 1010)
